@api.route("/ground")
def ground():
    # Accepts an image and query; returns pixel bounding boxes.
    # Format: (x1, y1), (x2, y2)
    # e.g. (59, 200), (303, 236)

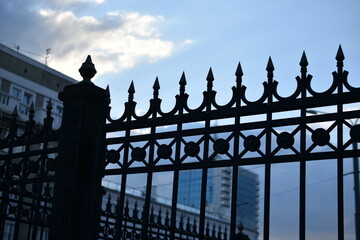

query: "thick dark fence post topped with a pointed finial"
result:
(50, 56), (110, 240)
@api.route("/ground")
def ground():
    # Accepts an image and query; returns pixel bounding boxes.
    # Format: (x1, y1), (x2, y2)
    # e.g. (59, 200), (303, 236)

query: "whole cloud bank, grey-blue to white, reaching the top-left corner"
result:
(0, 0), (191, 80)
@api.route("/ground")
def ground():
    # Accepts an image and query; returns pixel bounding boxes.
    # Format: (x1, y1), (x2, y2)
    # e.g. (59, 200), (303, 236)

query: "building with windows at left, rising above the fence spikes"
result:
(0, 44), (77, 132)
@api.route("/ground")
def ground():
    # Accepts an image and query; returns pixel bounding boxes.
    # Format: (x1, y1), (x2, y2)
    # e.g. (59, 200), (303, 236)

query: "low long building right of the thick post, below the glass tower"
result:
(100, 179), (230, 239)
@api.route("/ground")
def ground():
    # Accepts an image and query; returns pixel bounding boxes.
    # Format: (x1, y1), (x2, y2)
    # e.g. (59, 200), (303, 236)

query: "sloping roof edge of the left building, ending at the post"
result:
(0, 43), (79, 83)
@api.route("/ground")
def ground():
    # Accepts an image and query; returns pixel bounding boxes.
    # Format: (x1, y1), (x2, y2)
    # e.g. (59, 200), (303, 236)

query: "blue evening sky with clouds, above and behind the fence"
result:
(0, 0), (360, 239)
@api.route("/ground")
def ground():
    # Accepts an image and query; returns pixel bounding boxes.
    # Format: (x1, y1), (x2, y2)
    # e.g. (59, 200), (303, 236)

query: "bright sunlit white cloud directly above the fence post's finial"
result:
(38, 9), (174, 77)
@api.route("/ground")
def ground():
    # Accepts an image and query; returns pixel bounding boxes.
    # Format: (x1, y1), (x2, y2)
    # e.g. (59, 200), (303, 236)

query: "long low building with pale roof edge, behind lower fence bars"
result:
(100, 179), (230, 239)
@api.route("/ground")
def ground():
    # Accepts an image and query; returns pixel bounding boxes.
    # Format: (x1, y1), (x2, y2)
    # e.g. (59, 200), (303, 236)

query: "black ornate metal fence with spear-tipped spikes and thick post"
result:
(0, 47), (360, 239)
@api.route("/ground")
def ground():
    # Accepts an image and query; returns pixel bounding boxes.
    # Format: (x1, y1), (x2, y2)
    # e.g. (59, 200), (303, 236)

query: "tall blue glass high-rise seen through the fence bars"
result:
(178, 167), (259, 240)
